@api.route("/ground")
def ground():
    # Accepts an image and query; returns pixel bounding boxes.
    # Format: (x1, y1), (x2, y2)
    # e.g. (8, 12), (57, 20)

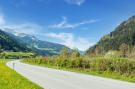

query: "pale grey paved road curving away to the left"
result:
(7, 61), (135, 89)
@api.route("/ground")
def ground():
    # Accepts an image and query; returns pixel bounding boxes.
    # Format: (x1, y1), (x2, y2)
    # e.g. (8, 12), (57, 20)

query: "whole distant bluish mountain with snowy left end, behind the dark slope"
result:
(4, 28), (70, 55)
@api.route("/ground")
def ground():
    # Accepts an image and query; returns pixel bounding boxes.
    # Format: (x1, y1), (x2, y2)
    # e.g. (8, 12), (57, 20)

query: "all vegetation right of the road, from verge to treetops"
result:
(23, 48), (135, 82)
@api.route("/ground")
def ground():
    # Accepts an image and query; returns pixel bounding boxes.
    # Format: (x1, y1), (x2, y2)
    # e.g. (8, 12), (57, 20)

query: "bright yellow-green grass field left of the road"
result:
(0, 59), (43, 89)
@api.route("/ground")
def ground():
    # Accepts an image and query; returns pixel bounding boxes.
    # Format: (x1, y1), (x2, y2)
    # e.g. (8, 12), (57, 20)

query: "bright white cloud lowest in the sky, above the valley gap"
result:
(46, 33), (93, 51)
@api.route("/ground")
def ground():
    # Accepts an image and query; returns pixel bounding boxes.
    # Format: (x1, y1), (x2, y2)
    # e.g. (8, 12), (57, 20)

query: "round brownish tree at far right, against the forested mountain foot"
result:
(119, 43), (129, 57)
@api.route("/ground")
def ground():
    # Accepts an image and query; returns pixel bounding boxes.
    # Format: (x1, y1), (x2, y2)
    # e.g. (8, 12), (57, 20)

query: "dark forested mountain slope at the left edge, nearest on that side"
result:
(0, 30), (30, 51)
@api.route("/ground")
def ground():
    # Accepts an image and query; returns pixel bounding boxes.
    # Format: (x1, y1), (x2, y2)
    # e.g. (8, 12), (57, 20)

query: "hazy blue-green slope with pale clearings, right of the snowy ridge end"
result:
(18, 35), (69, 55)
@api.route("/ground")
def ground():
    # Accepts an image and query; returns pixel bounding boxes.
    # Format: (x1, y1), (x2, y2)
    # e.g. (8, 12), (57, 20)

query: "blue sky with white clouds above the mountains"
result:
(0, 0), (135, 50)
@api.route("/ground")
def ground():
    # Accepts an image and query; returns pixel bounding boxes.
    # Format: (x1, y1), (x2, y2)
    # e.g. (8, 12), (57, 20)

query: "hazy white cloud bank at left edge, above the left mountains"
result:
(0, 13), (42, 34)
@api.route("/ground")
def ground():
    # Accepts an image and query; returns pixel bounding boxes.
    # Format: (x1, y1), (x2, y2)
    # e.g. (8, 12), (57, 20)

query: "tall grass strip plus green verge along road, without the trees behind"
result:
(23, 56), (135, 82)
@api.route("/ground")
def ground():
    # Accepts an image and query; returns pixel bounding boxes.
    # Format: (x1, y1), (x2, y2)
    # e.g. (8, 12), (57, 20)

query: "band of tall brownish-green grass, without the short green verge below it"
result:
(24, 57), (135, 76)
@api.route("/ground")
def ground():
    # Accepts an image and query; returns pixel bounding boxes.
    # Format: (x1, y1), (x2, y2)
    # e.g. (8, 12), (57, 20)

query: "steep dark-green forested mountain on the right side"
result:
(87, 16), (135, 54)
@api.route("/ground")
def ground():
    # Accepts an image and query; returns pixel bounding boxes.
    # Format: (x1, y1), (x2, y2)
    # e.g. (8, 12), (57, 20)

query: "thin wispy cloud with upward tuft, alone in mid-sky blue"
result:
(49, 17), (97, 29)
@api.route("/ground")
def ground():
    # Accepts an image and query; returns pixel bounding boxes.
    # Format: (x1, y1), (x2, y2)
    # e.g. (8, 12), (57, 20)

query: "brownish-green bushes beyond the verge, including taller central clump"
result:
(24, 50), (135, 77)
